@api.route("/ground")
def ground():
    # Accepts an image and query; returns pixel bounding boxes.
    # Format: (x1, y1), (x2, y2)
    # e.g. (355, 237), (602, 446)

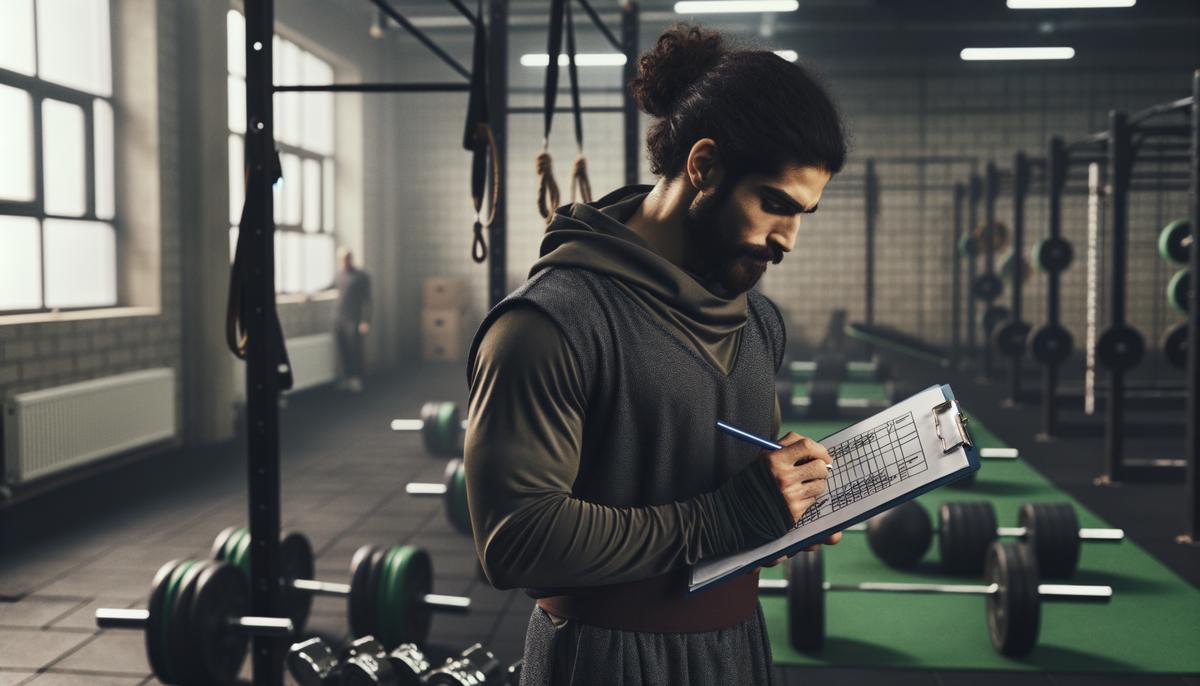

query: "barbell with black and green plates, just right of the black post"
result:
(212, 526), (470, 648)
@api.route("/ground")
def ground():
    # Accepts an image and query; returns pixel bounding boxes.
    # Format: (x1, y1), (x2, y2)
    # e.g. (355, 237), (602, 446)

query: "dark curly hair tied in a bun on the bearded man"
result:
(629, 24), (847, 177)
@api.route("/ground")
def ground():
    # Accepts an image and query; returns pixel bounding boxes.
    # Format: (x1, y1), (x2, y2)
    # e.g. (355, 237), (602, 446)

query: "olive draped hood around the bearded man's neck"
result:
(529, 186), (746, 373)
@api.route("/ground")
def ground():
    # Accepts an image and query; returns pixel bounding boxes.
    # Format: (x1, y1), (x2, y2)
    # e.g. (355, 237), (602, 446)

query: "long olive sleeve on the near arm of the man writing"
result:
(464, 307), (791, 589)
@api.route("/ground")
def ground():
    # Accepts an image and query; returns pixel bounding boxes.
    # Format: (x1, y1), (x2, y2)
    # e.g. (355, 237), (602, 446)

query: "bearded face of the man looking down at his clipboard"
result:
(686, 167), (829, 295)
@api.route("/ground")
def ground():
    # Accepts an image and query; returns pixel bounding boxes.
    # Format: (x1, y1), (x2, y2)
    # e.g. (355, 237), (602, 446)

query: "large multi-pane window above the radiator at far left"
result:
(0, 0), (118, 313)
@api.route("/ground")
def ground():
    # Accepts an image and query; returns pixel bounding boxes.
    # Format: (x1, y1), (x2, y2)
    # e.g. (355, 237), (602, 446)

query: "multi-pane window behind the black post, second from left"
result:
(227, 11), (335, 294)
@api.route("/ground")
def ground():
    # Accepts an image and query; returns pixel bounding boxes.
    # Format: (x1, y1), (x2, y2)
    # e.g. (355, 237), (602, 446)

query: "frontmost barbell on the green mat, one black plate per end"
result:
(758, 541), (1112, 656)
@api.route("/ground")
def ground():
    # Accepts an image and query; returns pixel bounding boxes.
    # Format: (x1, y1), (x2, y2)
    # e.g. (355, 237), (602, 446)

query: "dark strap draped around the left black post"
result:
(226, 151), (300, 391)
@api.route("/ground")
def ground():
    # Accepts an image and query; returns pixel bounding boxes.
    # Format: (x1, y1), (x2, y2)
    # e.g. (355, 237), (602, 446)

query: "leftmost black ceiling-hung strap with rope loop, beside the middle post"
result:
(462, 0), (500, 264)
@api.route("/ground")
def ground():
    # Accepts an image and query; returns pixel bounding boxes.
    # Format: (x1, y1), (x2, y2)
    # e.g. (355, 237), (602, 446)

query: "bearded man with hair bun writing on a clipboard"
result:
(464, 26), (846, 686)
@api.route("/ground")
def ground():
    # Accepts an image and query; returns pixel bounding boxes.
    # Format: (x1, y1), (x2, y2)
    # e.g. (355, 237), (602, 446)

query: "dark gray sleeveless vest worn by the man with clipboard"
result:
(467, 267), (785, 507)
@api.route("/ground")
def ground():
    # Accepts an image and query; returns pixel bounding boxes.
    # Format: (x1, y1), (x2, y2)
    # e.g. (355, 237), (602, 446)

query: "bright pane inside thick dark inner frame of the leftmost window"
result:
(42, 100), (88, 217)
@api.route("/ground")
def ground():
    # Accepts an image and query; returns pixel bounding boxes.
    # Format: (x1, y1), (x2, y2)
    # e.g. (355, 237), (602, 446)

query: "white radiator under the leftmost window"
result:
(4, 368), (176, 483)
